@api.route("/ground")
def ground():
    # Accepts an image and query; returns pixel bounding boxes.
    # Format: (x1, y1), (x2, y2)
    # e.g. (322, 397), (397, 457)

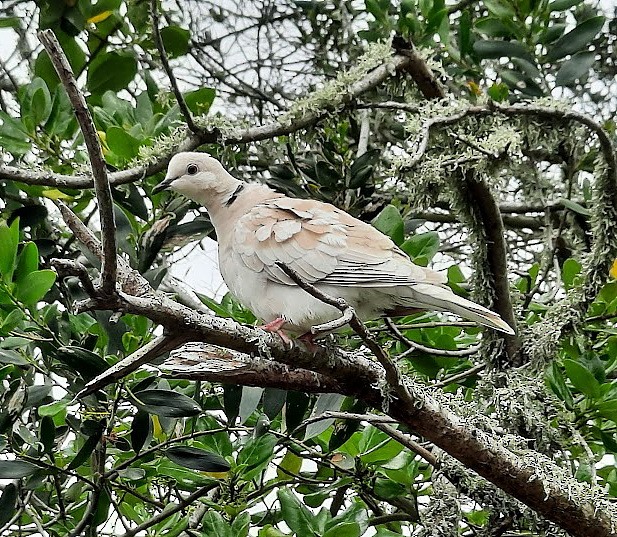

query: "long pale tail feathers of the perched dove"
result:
(387, 284), (514, 335)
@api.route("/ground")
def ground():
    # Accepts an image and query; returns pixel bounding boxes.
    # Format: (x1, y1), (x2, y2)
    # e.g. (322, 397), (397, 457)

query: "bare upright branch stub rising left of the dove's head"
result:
(39, 30), (116, 293)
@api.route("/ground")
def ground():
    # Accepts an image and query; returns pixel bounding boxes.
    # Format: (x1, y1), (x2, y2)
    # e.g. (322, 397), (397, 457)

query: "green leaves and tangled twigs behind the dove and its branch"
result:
(0, 0), (617, 537)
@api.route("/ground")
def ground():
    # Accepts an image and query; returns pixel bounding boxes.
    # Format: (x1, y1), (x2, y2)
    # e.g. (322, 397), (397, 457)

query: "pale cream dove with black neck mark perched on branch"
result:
(152, 152), (514, 341)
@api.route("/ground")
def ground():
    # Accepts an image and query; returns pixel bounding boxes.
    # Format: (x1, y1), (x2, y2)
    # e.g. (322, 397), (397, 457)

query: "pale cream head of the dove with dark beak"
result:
(152, 152), (239, 207)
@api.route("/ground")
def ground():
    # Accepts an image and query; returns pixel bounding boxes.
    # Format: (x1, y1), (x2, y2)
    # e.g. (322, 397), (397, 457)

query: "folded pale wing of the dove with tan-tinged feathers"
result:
(233, 197), (446, 287)
